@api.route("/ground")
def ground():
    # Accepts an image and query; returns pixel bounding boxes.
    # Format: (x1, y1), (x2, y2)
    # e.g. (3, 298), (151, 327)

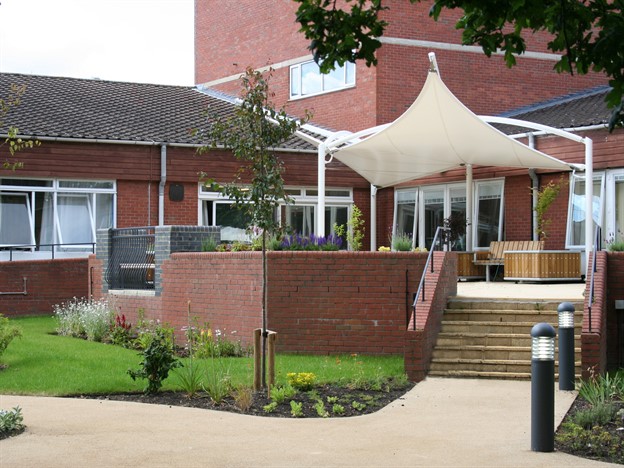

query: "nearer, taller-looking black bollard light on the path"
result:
(531, 323), (556, 452)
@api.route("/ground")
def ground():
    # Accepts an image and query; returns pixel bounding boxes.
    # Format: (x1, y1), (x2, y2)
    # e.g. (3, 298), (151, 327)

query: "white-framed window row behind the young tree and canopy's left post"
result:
(199, 185), (353, 246)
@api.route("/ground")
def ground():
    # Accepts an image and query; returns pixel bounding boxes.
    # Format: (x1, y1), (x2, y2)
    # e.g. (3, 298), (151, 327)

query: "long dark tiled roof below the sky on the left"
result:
(0, 73), (315, 151)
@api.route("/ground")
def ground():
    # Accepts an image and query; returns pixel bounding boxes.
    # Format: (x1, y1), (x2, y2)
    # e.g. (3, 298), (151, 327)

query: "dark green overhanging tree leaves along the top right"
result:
(295, 0), (624, 130)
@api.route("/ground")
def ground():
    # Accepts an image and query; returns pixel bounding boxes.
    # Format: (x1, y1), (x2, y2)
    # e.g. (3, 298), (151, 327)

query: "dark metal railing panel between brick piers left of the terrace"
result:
(106, 226), (156, 289)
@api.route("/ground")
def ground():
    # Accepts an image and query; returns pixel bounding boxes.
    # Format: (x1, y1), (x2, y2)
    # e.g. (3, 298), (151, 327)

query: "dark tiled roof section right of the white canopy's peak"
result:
(497, 86), (611, 133)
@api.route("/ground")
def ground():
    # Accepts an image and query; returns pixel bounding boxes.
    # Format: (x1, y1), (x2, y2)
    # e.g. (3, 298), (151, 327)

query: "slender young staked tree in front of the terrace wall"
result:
(199, 68), (309, 387)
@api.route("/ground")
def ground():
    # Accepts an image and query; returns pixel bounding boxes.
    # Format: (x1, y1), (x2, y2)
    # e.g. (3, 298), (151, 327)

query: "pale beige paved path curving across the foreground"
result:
(0, 378), (616, 468)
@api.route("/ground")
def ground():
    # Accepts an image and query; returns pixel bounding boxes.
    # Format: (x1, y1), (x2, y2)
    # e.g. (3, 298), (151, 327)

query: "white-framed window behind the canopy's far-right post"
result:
(566, 172), (605, 249)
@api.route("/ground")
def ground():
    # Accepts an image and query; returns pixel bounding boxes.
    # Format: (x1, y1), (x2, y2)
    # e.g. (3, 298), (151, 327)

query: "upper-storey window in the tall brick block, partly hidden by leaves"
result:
(290, 61), (355, 99)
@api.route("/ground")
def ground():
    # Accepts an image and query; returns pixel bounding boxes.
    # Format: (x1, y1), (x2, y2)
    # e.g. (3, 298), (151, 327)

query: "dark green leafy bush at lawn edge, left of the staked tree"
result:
(128, 329), (181, 394)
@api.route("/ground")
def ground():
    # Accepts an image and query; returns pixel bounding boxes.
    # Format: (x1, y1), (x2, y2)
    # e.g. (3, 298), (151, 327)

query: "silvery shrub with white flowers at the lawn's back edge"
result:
(54, 298), (114, 341)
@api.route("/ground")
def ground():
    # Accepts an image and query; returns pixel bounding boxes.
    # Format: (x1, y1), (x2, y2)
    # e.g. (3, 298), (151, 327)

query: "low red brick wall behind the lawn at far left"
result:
(0, 258), (88, 317)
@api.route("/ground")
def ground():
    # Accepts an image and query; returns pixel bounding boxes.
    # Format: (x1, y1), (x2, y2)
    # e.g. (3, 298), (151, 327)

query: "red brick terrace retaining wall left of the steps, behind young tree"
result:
(103, 252), (434, 354)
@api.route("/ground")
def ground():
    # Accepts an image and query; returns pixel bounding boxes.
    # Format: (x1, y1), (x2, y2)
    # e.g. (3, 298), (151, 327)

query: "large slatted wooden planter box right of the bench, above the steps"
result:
(504, 250), (581, 281)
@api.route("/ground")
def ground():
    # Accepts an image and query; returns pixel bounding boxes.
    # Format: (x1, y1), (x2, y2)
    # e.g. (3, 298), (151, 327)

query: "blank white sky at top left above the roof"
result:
(0, 0), (194, 86)
